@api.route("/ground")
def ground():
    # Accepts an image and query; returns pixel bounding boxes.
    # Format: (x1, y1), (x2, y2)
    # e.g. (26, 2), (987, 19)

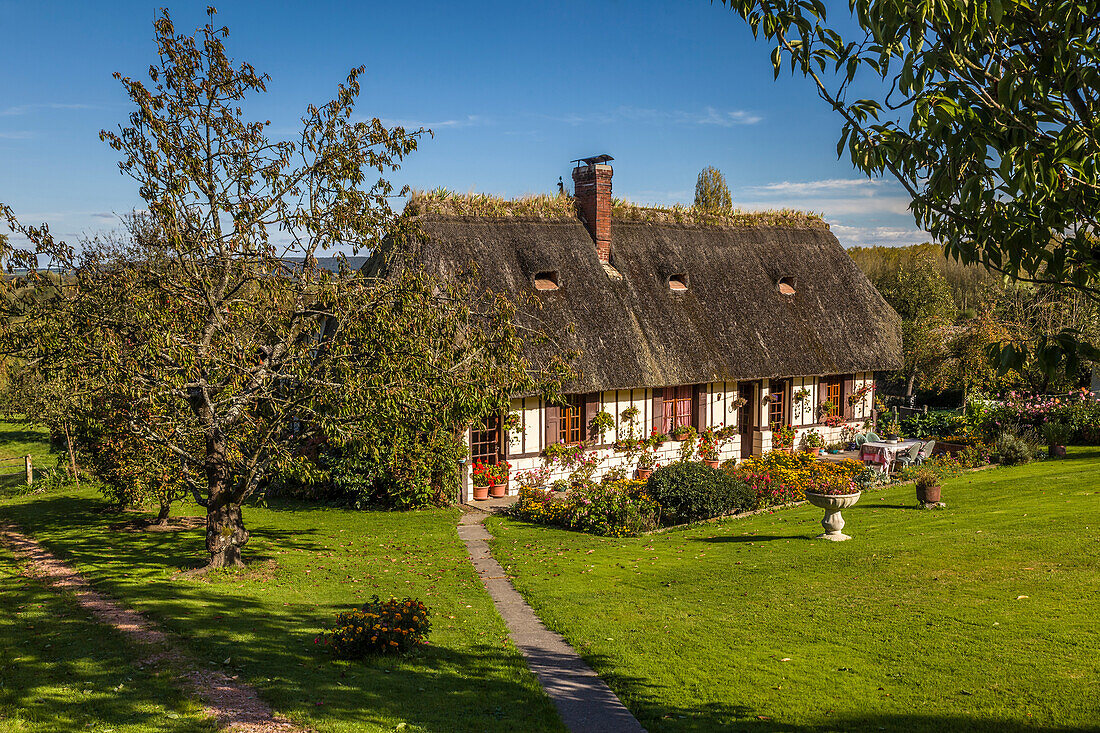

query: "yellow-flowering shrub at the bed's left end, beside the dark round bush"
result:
(508, 480), (658, 537)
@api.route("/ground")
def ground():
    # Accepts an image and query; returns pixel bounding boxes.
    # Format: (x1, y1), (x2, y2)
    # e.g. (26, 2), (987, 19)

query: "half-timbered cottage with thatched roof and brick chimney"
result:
(374, 156), (901, 499)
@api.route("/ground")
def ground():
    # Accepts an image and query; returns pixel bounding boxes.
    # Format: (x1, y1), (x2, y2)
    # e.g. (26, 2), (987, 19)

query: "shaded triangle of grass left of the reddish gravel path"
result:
(0, 547), (215, 733)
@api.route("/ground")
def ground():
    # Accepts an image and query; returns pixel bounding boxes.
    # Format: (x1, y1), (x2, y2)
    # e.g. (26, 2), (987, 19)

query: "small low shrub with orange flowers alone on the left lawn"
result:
(314, 595), (431, 659)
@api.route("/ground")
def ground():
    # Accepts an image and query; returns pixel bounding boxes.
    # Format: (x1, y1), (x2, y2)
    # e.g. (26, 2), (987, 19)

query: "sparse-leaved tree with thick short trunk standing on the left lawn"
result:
(4, 10), (554, 567)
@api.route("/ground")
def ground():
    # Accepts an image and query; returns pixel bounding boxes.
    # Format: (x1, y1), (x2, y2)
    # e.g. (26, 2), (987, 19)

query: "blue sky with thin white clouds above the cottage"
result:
(0, 0), (927, 245)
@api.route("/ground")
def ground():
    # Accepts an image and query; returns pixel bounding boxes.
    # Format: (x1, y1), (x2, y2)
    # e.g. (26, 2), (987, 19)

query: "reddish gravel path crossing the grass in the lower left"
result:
(0, 524), (306, 733)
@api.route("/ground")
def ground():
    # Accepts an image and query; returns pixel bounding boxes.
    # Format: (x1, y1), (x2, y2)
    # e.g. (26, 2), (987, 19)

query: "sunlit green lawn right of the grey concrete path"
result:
(488, 449), (1100, 733)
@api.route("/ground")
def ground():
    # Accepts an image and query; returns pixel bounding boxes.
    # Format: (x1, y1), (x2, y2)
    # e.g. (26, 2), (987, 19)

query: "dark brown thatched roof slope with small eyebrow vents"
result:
(367, 214), (901, 392)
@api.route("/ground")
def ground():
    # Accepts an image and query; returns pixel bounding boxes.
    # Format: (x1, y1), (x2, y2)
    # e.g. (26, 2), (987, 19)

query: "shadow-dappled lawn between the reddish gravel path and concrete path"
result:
(0, 490), (563, 733)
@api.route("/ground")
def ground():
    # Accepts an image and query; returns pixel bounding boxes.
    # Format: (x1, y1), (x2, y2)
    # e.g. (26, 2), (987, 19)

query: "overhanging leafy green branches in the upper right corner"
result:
(724, 0), (1100, 369)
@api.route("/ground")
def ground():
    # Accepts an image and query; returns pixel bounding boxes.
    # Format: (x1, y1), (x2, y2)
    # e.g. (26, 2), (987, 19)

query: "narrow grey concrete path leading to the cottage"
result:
(459, 510), (645, 733)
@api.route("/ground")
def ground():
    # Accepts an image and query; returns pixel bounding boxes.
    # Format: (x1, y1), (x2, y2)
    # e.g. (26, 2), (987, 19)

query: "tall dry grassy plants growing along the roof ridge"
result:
(405, 188), (824, 227)
